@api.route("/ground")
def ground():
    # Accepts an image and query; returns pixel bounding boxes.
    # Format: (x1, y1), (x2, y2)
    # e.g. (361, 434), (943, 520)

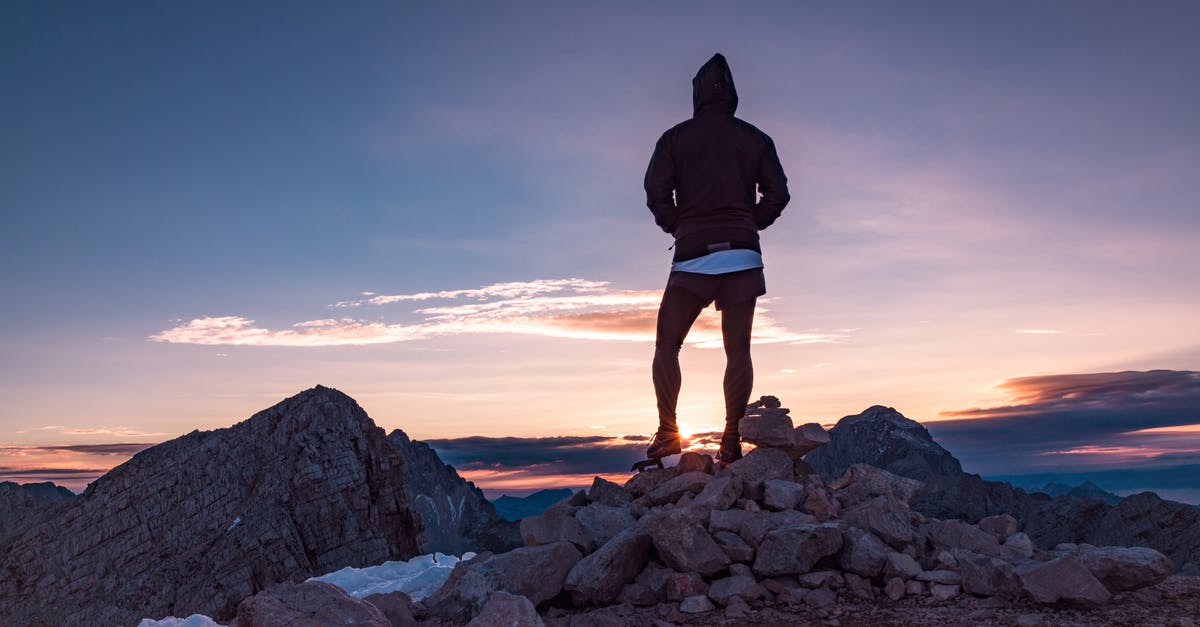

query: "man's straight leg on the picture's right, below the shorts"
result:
(720, 293), (757, 462)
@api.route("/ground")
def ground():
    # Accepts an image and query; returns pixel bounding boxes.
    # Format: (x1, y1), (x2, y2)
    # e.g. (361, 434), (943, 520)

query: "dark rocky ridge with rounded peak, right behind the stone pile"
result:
(805, 406), (1200, 574)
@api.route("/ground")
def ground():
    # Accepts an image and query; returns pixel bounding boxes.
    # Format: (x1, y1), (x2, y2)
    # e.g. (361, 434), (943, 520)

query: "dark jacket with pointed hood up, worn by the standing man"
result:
(646, 54), (791, 261)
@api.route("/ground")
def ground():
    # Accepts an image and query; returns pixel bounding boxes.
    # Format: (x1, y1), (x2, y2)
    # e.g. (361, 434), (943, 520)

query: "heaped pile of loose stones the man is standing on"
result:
(413, 396), (1171, 625)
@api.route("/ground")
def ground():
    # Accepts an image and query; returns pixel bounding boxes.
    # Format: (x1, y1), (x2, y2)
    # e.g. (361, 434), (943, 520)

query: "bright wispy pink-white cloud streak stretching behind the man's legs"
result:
(150, 279), (850, 348)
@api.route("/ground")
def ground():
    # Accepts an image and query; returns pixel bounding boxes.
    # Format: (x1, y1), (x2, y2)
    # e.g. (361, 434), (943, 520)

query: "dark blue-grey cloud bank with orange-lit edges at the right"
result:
(926, 370), (1200, 474)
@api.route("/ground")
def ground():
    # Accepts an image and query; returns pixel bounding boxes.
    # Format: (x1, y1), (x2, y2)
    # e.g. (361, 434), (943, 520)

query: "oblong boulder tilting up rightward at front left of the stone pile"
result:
(563, 525), (650, 605)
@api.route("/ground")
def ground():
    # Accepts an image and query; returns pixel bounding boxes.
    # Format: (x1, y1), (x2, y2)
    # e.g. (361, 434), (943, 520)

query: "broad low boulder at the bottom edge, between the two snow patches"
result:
(231, 581), (391, 627)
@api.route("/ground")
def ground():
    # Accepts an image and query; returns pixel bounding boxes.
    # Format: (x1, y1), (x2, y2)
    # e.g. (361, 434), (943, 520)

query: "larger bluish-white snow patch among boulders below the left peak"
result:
(308, 553), (475, 601)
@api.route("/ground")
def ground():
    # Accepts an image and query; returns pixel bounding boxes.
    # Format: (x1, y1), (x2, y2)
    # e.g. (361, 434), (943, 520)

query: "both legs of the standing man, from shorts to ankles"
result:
(653, 286), (756, 431)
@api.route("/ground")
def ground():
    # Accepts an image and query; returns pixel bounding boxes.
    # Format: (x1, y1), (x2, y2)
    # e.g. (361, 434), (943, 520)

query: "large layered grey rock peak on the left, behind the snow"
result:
(0, 386), (513, 625)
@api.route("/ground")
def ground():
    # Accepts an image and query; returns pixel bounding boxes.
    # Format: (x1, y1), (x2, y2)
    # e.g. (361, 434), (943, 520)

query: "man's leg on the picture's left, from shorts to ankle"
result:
(652, 286), (708, 442)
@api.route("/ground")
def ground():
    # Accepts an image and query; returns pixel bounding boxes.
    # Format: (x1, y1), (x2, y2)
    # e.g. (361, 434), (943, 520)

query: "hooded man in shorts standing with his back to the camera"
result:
(646, 54), (790, 464)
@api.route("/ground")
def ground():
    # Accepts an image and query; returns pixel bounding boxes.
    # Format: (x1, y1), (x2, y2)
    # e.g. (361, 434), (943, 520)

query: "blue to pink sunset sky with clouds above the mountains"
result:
(0, 1), (1200, 502)
